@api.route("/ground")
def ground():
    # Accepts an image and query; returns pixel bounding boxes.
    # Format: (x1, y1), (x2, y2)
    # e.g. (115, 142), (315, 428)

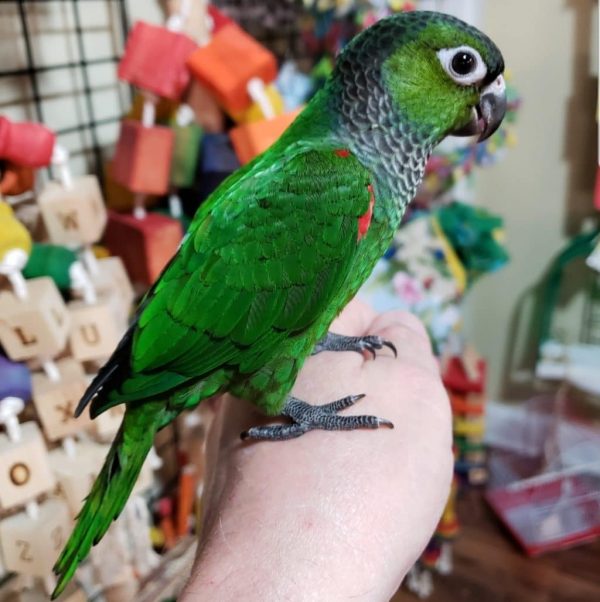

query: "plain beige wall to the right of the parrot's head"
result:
(466, 0), (597, 399)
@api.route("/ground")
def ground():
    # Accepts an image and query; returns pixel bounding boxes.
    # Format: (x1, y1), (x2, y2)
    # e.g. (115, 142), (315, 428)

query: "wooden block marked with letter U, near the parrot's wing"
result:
(67, 300), (123, 362)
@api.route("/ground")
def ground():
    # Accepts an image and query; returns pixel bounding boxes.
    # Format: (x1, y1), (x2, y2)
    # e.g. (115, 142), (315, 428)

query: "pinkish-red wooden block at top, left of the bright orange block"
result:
(118, 21), (196, 100)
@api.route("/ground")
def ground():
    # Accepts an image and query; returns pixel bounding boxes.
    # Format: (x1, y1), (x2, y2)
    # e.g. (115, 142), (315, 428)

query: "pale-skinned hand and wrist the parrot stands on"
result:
(178, 301), (453, 602)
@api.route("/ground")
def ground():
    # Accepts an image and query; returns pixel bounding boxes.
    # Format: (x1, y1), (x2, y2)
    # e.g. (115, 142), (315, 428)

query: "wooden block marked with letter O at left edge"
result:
(0, 422), (55, 508)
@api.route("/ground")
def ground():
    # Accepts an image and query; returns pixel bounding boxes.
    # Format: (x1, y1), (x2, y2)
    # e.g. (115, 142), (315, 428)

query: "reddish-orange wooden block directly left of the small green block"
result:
(112, 119), (174, 194)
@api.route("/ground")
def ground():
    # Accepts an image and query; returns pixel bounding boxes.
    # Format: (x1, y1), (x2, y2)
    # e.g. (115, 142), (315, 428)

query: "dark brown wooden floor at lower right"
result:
(393, 491), (600, 602)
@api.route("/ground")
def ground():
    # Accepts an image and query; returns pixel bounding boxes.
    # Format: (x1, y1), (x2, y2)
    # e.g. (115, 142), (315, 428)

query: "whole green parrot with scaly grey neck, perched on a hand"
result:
(54, 11), (506, 597)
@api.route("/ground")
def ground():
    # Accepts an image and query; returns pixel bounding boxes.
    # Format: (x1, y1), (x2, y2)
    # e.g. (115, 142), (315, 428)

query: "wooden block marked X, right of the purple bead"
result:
(32, 358), (91, 441)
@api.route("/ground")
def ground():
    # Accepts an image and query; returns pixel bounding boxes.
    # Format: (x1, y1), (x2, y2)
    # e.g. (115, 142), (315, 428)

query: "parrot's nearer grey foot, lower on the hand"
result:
(241, 394), (394, 441)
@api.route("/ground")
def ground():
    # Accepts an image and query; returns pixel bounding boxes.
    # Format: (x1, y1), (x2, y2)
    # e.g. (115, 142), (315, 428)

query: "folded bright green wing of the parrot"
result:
(92, 149), (370, 415)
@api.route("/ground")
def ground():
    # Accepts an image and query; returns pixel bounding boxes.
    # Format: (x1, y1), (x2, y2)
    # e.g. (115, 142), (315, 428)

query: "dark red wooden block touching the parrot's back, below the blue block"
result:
(104, 211), (183, 286)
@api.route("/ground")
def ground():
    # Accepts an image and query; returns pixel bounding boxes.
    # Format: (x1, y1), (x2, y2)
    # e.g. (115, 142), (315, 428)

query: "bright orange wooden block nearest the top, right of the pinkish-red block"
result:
(187, 23), (277, 113)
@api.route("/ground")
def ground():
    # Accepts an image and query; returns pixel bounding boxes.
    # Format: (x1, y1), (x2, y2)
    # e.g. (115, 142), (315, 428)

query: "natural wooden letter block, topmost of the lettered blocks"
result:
(38, 176), (106, 246)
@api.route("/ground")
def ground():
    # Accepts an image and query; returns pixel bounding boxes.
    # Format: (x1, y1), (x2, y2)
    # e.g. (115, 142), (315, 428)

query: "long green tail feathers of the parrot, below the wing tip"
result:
(52, 402), (165, 600)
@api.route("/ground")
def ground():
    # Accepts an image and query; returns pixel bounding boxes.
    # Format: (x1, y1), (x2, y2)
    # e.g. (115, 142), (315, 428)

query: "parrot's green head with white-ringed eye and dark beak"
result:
(339, 11), (506, 143)
